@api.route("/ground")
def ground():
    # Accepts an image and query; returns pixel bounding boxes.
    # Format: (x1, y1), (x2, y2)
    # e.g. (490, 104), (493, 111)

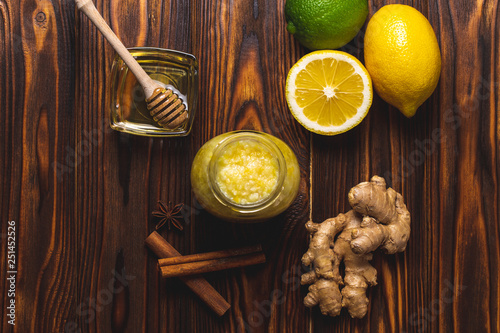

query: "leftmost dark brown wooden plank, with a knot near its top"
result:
(0, 0), (77, 332)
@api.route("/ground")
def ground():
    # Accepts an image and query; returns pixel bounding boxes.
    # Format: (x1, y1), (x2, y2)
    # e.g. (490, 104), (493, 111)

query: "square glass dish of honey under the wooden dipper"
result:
(108, 47), (198, 137)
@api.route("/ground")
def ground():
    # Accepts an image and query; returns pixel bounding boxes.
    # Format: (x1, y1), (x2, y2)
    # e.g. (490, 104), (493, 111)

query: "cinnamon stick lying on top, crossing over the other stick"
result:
(160, 252), (266, 278)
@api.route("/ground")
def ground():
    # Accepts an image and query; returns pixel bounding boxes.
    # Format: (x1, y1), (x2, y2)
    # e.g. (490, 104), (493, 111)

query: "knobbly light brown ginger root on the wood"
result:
(301, 176), (410, 318)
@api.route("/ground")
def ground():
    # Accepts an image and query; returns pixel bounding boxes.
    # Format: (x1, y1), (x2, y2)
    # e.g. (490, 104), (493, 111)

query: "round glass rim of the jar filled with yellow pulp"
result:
(208, 131), (286, 214)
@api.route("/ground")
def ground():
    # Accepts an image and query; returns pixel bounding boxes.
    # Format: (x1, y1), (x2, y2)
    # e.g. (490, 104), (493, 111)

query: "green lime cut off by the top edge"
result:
(285, 0), (368, 50)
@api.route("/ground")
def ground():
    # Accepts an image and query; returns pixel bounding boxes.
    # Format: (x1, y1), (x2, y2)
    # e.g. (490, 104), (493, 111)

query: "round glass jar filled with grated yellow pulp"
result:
(191, 131), (300, 222)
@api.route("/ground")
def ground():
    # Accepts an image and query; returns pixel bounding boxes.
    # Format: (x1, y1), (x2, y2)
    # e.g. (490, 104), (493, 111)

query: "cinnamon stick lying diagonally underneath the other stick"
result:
(145, 231), (231, 316)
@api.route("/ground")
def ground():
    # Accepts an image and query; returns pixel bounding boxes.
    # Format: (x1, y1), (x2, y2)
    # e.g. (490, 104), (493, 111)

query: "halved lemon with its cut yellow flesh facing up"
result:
(286, 50), (373, 135)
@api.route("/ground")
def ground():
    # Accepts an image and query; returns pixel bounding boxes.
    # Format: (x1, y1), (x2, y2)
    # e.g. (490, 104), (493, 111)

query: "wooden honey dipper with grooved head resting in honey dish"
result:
(75, 0), (188, 129)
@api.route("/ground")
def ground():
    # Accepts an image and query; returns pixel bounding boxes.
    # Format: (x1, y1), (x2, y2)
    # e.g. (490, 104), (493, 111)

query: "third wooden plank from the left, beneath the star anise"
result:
(145, 0), (202, 332)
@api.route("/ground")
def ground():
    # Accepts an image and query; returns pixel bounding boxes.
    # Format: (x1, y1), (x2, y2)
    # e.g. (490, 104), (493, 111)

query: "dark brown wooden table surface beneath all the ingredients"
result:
(0, 0), (500, 333)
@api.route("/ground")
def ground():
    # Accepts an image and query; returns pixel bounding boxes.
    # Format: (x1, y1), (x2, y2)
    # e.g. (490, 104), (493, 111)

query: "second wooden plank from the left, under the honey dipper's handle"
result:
(75, 1), (151, 332)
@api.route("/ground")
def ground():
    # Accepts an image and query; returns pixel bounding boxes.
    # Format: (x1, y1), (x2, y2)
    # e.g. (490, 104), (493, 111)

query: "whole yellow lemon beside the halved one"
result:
(365, 5), (441, 117)
